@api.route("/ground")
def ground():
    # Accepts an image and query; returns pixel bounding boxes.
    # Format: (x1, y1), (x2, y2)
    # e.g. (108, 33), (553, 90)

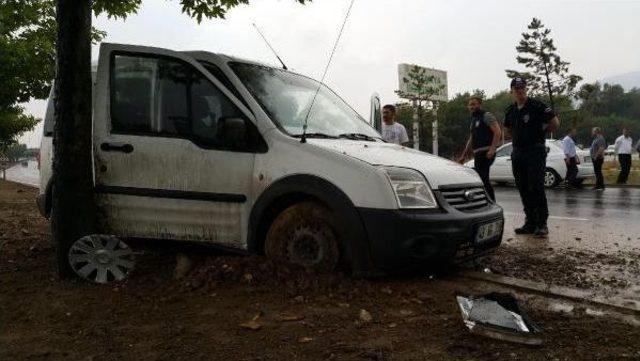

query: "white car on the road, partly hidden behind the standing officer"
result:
(465, 139), (595, 188)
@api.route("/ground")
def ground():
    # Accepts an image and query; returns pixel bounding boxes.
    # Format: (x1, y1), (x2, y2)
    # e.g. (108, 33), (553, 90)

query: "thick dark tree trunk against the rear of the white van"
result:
(51, 0), (96, 277)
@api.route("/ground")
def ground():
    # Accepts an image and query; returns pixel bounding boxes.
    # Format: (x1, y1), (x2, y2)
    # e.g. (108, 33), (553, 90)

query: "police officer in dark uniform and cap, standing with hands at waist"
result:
(504, 77), (560, 236)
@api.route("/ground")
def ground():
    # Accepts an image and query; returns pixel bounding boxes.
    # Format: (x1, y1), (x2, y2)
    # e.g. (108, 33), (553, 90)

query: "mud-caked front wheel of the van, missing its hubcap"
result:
(264, 202), (340, 272)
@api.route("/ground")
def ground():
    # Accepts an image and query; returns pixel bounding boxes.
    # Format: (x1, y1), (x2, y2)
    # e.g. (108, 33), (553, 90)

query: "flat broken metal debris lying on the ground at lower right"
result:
(456, 293), (542, 345)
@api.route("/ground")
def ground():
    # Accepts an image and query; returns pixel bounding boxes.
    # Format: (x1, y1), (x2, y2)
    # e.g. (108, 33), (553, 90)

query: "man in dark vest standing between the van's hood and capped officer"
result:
(458, 96), (502, 201)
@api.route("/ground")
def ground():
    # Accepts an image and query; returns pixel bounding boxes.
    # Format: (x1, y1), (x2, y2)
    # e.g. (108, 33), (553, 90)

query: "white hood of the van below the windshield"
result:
(308, 139), (482, 189)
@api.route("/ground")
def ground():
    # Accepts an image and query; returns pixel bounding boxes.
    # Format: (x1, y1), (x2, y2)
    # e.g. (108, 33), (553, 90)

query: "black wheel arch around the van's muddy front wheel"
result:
(247, 175), (373, 276)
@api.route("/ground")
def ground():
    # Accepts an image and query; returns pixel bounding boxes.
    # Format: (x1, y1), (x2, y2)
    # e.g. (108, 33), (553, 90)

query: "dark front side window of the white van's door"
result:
(111, 55), (249, 149)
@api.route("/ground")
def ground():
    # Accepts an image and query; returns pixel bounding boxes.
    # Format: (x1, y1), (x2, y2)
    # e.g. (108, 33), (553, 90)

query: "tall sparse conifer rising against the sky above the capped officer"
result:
(506, 18), (582, 109)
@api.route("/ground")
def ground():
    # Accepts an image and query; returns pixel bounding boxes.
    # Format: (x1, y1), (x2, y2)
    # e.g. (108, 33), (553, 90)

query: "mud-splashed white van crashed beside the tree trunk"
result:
(38, 43), (503, 274)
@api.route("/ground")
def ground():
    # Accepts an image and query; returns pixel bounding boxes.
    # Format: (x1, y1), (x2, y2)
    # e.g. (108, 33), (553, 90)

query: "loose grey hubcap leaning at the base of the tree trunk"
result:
(69, 235), (135, 283)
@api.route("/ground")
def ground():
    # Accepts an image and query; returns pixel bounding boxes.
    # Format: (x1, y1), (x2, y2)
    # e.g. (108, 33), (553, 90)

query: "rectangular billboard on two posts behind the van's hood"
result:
(396, 64), (448, 155)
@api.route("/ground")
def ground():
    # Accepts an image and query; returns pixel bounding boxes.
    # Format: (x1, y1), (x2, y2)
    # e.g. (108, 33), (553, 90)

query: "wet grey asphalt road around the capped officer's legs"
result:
(495, 186), (640, 253)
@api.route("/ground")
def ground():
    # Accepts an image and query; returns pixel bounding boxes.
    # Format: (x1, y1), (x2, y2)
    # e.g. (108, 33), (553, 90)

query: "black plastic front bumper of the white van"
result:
(359, 203), (504, 270)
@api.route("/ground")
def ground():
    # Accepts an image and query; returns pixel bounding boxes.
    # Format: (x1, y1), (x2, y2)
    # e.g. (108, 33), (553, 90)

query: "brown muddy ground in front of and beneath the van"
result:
(0, 182), (640, 360)
